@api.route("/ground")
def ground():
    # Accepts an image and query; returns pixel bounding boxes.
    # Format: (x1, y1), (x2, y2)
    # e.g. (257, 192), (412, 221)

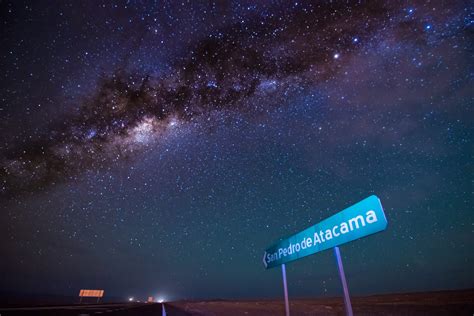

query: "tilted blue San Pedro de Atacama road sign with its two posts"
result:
(263, 195), (387, 316)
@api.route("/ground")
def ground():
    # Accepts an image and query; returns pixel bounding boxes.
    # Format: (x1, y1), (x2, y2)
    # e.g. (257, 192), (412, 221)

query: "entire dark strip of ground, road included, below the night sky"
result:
(0, 289), (474, 316)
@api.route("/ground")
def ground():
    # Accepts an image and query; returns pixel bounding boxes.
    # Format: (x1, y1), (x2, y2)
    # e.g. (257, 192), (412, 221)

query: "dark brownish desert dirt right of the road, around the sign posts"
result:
(166, 290), (474, 316)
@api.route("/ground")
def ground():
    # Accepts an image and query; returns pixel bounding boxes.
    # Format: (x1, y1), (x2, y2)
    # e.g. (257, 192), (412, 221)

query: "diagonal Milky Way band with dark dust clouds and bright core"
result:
(1, 4), (426, 196)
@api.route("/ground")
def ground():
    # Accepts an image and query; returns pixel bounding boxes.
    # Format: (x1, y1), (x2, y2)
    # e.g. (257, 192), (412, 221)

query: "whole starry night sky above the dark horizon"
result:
(0, 1), (474, 300)
